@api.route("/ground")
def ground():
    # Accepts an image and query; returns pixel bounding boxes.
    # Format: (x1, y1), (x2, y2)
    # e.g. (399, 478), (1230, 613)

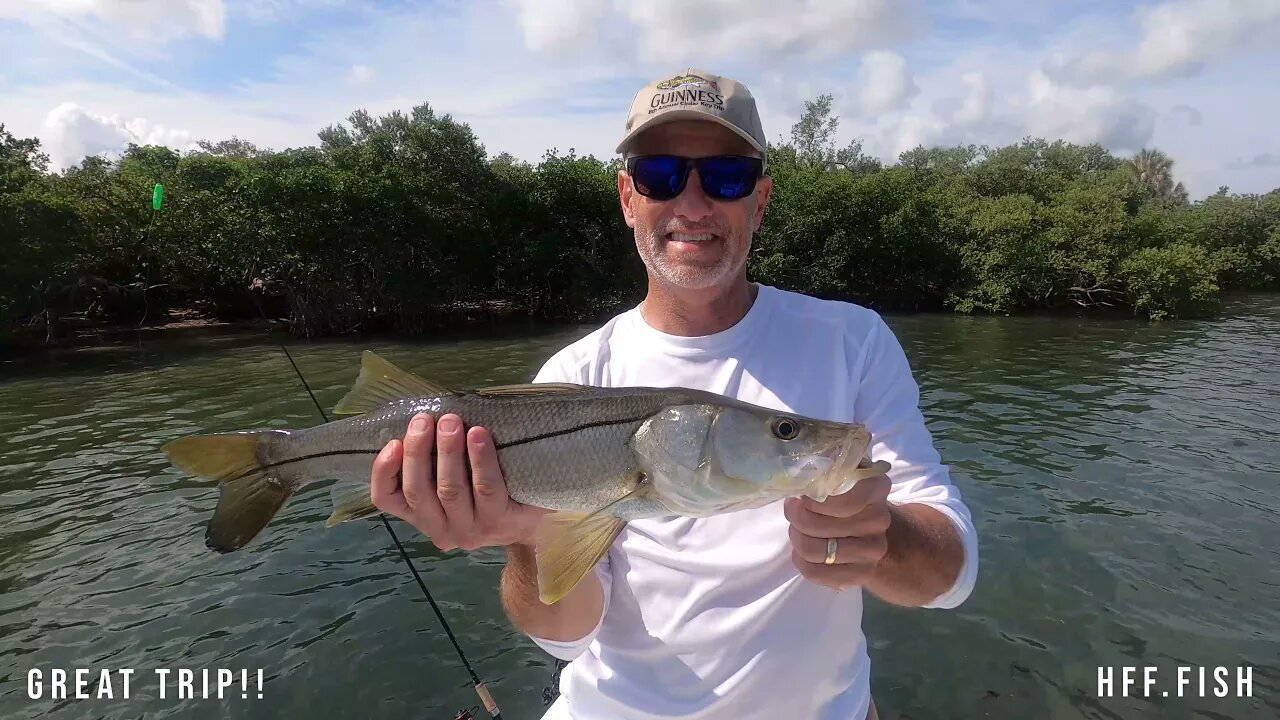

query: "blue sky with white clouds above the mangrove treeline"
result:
(0, 0), (1280, 199)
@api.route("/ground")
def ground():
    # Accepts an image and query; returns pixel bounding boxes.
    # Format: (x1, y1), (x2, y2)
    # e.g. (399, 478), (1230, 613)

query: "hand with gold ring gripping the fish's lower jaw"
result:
(782, 475), (892, 591)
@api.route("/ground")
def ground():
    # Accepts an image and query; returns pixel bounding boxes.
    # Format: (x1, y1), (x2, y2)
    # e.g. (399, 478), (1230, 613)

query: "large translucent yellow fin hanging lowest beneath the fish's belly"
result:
(536, 512), (626, 605)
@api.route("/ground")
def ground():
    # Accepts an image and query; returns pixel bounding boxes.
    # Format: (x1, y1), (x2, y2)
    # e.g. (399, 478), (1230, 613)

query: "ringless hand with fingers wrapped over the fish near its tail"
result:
(369, 414), (549, 551)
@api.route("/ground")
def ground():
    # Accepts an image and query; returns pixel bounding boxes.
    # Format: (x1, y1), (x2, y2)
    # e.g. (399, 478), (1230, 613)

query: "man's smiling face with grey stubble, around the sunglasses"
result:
(618, 120), (773, 290)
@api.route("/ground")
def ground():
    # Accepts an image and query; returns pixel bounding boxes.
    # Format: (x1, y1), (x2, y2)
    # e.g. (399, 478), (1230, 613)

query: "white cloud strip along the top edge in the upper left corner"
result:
(0, 0), (227, 40)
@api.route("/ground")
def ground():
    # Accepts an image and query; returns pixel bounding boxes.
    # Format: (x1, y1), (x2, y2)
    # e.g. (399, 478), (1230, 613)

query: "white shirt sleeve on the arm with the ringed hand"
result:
(855, 315), (978, 609)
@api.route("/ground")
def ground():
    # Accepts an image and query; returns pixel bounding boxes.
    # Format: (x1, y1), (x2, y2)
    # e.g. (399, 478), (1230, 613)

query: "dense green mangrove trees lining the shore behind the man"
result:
(0, 95), (1280, 336)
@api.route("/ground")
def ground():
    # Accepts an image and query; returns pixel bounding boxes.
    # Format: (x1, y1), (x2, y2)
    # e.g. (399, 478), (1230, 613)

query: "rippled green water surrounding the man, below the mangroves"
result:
(0, 297), (1280, 720)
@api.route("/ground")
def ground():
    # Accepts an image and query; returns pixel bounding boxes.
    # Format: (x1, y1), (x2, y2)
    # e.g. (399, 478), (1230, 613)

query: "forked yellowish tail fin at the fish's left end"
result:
(164, 430), (298, 552)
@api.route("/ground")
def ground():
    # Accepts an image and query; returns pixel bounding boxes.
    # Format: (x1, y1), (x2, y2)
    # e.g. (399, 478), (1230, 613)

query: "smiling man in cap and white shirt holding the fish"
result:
(371, 69), (978, 720)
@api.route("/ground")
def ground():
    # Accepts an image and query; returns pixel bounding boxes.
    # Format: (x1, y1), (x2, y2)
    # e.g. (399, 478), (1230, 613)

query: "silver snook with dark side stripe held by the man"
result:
(164, 351), (888, 605)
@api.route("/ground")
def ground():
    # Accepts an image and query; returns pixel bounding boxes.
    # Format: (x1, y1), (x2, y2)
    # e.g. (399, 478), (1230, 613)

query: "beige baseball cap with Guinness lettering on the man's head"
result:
(616, 68), (768, 162)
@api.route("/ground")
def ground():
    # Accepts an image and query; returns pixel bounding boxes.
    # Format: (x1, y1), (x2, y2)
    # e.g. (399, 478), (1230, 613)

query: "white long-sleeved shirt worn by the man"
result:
(532, 286), (978, 720)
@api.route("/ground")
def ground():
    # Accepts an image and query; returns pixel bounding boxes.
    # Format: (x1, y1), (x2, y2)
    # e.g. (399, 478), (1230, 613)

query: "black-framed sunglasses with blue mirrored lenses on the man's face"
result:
(627, 155), (764, 200)
